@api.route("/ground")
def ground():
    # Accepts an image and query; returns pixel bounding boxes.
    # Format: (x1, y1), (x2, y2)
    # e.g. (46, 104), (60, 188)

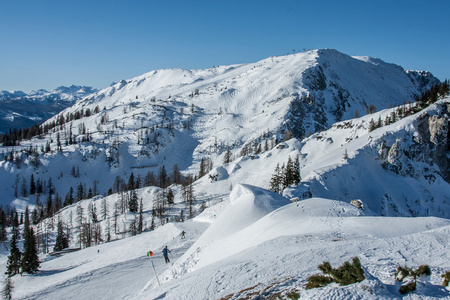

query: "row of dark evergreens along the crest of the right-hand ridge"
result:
(369, 80), (450, 131)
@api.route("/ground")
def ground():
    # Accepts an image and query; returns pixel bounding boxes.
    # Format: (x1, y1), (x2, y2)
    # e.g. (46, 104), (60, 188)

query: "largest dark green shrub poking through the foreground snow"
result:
(306, 256), (366, 289)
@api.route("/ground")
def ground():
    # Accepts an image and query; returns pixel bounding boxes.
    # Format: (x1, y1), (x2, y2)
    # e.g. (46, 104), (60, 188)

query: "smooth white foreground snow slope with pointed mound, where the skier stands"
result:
(7, 186), (450, 299)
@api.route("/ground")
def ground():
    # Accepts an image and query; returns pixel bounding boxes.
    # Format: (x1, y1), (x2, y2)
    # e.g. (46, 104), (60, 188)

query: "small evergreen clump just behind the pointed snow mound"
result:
(269, 155), (301, 194)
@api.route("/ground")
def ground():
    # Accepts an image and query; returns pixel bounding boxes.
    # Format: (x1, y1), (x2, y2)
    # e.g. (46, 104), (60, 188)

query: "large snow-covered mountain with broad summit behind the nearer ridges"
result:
(0, 49), (438, 204)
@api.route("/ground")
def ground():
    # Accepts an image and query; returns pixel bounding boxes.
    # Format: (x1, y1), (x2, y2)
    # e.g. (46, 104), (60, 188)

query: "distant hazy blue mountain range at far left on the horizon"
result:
(0, 85), (98, 134)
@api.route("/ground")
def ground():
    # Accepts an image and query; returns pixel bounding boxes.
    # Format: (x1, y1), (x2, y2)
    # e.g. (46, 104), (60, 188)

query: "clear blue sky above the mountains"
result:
(0, 0), (450, 92)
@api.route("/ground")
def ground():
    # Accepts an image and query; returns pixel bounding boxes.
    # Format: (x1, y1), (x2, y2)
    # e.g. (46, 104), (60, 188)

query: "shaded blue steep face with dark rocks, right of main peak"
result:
(285, 49), (439, 137)
